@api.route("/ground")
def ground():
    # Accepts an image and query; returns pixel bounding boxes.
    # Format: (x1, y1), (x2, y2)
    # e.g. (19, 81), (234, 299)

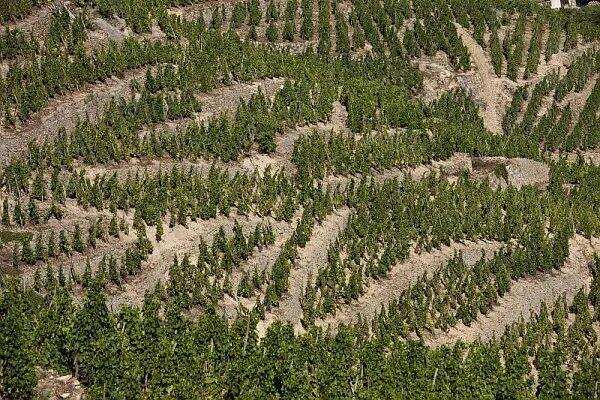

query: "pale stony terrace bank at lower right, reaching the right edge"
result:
(427, 235), (600, 347)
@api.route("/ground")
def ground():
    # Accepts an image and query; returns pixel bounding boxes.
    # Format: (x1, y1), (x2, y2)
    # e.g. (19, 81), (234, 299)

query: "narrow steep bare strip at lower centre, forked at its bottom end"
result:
(257, 207), (350, 337)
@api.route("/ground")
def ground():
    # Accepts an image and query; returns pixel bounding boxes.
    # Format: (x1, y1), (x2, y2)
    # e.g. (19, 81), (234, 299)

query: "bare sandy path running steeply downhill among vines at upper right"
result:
(455, 24), (516, 133)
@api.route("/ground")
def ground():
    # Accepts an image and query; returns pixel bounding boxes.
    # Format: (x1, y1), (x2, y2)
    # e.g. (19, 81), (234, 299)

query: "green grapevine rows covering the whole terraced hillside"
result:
(0, 0), (600, 399)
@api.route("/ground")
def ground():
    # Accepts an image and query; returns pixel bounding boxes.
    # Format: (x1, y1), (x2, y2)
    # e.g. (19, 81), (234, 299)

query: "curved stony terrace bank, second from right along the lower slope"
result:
(316, 241), (502, 329)
